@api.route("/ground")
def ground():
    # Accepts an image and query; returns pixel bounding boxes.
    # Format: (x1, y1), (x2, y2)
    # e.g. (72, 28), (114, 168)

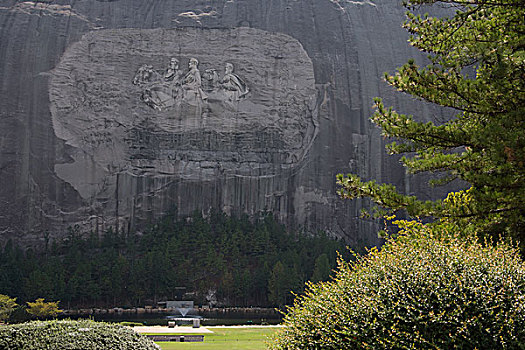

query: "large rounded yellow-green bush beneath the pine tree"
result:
(270, 223), (525, 349)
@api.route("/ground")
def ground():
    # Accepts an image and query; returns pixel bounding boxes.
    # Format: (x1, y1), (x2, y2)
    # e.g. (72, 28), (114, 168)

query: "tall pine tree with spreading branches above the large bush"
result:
(338, 0), (525, 249)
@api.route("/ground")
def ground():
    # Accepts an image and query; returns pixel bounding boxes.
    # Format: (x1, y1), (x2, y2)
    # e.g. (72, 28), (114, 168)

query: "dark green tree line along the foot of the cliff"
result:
(0, 209), (348, 307)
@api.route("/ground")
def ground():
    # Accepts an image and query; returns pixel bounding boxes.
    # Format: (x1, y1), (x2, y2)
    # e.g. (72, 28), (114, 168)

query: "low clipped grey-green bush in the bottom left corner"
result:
(0, 320), (160, 350)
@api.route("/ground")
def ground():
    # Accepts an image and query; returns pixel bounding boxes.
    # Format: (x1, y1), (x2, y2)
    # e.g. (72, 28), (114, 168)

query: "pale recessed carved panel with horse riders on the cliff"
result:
(49, 28), (318, 227)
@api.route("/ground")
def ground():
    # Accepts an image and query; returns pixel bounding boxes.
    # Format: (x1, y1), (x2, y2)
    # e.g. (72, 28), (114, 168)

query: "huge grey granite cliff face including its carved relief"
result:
(0, 0), (446, 249)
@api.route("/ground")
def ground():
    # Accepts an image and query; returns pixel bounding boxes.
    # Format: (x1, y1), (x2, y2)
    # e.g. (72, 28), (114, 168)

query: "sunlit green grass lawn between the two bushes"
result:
(157, 327), (277, 350)
